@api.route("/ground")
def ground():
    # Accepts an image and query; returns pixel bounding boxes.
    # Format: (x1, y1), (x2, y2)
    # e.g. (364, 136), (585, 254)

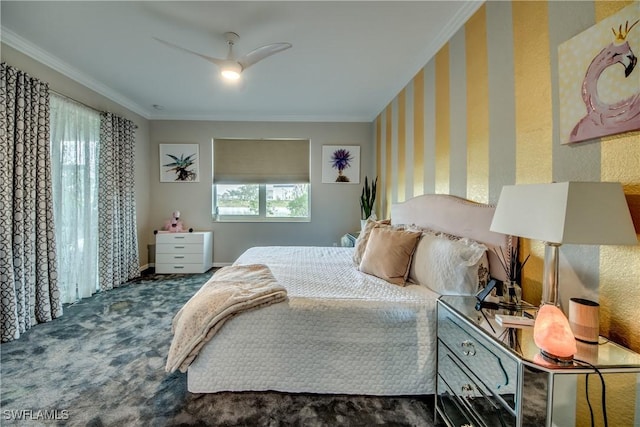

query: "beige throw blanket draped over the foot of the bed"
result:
(165, 264), (287, 372)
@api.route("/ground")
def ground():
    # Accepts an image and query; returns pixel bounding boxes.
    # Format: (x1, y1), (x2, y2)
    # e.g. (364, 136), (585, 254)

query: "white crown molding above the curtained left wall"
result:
(0, 25), (150, 120)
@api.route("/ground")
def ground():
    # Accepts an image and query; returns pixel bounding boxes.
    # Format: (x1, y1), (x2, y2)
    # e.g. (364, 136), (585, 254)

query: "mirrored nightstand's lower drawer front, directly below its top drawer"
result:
(437, 343), (516, 427)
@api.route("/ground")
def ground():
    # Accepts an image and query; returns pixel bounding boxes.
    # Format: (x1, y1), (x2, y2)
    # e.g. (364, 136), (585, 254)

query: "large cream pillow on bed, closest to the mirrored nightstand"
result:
(409, 233), (489, 295)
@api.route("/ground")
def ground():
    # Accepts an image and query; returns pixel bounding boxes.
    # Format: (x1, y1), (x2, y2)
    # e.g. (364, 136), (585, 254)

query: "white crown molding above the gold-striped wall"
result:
(378, 0), (485, 115)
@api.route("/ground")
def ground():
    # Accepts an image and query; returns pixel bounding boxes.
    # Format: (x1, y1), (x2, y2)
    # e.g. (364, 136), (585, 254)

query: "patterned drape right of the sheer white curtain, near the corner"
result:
(98, 113), (140, 291)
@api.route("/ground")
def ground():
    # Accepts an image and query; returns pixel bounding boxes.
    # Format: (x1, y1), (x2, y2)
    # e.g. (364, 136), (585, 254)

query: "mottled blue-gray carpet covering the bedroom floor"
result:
(0, 273), (440, 426)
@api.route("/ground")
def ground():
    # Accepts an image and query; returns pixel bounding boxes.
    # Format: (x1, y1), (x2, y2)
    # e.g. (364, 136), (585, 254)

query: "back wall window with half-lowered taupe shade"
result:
(213, 139), (311, 222)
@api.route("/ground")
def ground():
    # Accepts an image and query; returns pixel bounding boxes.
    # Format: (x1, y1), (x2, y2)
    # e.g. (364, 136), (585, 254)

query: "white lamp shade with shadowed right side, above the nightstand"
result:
(491, 182), (638, 245)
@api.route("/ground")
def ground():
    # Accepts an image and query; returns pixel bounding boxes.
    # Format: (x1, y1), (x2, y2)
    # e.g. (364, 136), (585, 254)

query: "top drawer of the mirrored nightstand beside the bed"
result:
(438, 305), (519, 411)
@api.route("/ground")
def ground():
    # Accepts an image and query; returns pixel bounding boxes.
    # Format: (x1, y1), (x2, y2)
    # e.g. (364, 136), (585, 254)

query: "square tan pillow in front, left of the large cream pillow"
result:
(359, 227), (422, 286)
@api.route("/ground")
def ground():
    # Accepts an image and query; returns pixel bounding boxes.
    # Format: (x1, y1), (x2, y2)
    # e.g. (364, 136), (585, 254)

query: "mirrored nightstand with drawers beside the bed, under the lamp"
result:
(436, 296), (640, 426)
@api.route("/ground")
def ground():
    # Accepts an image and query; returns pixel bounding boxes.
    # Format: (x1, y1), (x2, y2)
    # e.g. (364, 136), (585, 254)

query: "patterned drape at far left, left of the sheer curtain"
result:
(0, 63), (62, 342)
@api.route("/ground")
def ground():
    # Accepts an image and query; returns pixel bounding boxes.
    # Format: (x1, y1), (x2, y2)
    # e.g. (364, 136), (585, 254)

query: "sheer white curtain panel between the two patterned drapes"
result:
(50, 94), (100, 304)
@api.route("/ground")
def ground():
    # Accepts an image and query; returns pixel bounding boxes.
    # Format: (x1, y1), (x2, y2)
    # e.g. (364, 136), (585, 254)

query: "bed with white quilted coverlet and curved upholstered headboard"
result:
(182, 195), (512, 395)
